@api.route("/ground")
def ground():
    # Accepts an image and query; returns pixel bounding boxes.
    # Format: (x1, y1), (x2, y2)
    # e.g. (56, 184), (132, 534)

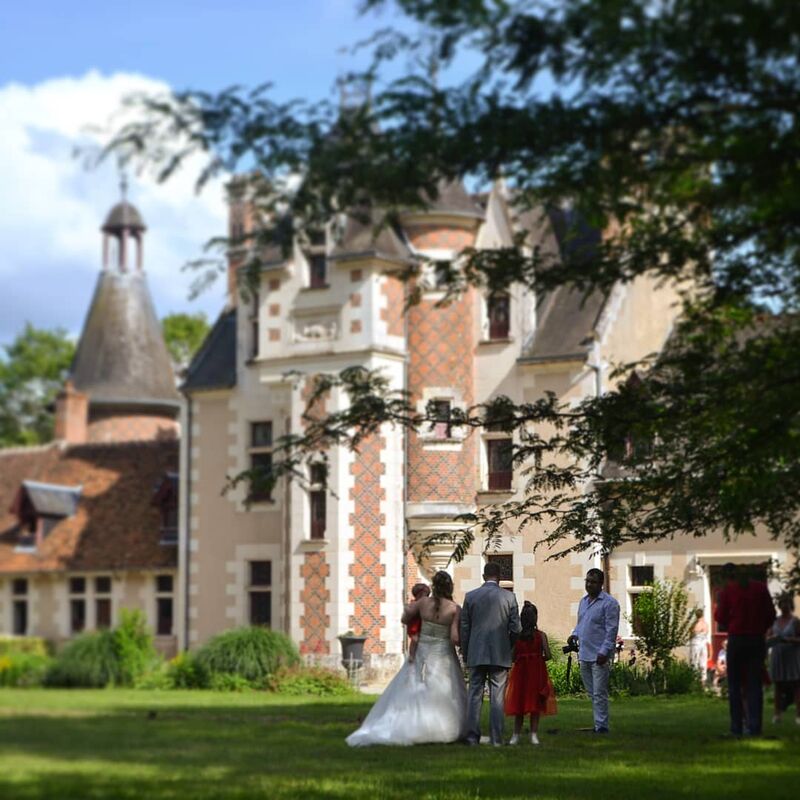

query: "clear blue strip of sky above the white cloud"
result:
(0, 0), (398, 97)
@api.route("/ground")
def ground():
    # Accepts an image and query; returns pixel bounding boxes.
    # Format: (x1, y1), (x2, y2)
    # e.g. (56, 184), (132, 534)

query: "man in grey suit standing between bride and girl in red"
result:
(461, 561), (522, 747)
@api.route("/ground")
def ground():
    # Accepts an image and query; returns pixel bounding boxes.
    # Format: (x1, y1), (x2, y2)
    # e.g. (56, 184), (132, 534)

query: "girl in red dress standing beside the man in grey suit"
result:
(506, 600), (556, 744)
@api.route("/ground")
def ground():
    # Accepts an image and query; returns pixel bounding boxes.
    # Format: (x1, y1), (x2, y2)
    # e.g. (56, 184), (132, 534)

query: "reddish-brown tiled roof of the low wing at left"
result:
(0, 440), (178, 574)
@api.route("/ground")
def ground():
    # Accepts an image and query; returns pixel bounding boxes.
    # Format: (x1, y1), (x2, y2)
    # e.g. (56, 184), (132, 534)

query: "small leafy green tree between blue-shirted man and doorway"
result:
(629, 580), (695, 669)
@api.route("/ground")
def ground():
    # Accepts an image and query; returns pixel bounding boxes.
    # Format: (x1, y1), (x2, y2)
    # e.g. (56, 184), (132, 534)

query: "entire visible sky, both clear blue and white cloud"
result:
(0, 0), (412, 344)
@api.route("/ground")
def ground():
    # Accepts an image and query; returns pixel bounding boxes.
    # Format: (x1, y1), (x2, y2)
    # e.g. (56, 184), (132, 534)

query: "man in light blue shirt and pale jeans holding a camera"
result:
(569, 569), (619, 733)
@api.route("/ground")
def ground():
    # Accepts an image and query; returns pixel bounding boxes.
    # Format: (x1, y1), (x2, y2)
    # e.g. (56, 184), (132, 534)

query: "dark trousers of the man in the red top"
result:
(727, 634), (766, 735)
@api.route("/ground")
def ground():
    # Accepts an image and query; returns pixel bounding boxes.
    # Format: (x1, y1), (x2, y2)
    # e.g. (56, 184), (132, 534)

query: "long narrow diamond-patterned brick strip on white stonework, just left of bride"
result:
(349, 436), (386, 653)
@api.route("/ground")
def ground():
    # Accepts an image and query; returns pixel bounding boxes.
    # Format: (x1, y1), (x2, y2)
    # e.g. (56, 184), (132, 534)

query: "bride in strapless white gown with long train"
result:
(347, 572), (467, 747)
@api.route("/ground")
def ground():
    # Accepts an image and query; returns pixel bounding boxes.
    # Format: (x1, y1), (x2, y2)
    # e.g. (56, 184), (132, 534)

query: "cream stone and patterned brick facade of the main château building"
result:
(181, 185), (787, 666)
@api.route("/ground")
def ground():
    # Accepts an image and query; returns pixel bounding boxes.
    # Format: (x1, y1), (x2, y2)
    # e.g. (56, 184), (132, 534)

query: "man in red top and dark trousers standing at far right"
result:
(714, 564), (775, 736)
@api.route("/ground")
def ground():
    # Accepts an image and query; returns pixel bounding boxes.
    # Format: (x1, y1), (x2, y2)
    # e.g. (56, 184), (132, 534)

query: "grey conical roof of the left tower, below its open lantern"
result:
(70, 271), (179, 410)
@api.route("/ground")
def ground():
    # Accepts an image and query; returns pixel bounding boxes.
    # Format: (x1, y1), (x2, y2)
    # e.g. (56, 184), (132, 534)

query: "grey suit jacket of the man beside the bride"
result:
(461, 581), (522, 667)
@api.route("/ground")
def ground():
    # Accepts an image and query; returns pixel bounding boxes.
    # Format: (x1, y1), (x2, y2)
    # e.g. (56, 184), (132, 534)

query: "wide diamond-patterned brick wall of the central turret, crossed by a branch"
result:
(408, 289), (478, 503)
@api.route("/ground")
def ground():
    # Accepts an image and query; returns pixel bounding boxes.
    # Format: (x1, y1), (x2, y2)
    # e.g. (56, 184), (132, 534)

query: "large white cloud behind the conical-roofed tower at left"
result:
(0, 71), (225, 342)
